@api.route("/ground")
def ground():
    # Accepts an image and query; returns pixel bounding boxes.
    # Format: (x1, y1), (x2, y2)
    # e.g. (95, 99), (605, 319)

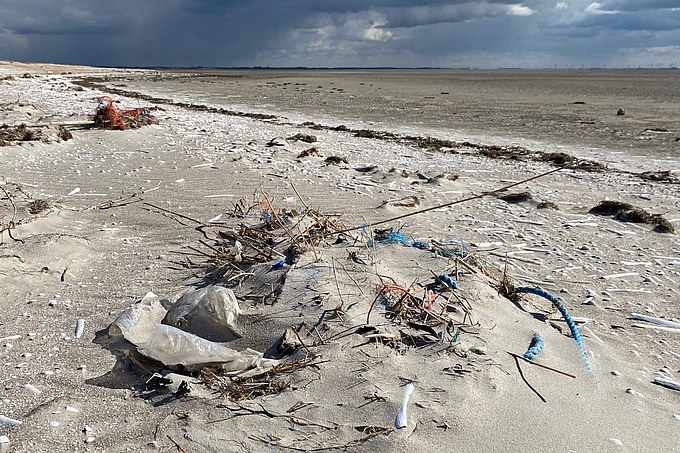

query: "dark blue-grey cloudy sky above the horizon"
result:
(0, 0), (680, 68)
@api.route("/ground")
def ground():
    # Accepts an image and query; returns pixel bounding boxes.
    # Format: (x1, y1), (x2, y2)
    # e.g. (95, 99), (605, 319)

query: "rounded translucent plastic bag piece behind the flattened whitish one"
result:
(163, 286), (243, 342)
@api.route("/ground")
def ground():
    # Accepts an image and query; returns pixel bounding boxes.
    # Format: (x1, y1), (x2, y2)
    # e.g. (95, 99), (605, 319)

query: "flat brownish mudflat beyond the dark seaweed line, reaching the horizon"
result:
(126, 70), (680, 159)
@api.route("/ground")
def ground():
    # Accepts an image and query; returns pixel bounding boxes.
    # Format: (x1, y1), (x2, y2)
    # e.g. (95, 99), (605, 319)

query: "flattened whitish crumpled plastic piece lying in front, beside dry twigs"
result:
(139, 324), (263, 371)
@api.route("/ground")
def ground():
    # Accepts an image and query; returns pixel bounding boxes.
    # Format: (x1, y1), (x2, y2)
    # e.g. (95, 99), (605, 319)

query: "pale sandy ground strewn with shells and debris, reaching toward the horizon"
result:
(0, 62), (680, 453)
